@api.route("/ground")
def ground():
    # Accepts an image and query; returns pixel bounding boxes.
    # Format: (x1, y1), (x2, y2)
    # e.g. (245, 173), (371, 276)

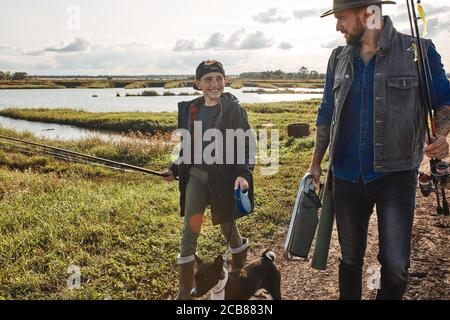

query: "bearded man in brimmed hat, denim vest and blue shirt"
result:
(309, 0), (450, 299)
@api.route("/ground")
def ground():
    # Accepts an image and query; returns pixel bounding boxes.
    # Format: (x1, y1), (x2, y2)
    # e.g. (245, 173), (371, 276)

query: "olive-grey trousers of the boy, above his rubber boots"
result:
(180, 167), (243, 257)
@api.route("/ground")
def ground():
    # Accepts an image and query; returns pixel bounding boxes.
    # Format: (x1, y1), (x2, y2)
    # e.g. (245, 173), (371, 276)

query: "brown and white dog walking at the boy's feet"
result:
(191, 250), (281, 300)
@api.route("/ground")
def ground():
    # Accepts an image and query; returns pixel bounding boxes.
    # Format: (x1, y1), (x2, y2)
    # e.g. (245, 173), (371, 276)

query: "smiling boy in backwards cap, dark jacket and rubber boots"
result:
(166, 60), (256, 300)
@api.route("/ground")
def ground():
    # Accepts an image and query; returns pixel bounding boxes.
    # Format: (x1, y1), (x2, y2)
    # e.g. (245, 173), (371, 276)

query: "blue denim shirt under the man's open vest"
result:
(316, 44), (450, 183)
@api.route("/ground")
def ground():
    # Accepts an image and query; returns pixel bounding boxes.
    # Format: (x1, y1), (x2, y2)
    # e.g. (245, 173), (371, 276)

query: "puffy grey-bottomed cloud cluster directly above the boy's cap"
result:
(173, 28), (274, 52)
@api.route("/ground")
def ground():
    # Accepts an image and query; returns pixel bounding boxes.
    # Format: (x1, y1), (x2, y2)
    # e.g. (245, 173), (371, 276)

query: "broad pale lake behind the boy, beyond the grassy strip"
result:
(0, 87), (323, 112)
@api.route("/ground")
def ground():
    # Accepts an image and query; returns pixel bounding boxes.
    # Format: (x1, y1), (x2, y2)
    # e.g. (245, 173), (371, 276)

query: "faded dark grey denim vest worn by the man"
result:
(330, 17), (431, 172)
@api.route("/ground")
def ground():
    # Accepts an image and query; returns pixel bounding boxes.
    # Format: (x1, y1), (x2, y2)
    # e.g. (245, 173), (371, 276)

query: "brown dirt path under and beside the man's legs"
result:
(250, 189), (450, 300)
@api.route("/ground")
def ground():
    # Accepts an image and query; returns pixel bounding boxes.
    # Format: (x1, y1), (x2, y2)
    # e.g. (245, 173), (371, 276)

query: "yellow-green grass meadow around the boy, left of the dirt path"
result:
(0, 101), (326, 299)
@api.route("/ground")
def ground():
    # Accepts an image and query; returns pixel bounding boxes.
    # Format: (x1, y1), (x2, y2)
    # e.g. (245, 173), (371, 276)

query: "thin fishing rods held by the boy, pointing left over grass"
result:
(0, 135), (172, 177)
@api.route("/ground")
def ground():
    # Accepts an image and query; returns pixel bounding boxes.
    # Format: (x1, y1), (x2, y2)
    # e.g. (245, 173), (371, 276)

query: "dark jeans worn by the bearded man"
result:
(333, 170), (417, 299)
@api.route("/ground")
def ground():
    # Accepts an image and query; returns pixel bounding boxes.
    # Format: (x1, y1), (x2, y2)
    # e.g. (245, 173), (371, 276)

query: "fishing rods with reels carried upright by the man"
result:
(406, 0), (450, 216)
